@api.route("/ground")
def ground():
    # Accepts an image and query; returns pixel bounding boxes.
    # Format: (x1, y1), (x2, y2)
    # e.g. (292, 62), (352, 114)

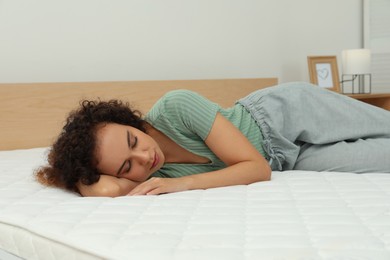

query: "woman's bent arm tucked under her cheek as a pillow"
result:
(77, 175), (139, 197)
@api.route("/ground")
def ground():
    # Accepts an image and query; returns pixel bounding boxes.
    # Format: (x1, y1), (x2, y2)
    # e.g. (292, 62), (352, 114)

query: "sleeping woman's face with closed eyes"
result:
(96, 123), (165, 182)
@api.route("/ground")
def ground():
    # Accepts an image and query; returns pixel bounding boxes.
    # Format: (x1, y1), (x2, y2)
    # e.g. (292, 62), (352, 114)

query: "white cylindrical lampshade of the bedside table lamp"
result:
(342, 49), (371, 75)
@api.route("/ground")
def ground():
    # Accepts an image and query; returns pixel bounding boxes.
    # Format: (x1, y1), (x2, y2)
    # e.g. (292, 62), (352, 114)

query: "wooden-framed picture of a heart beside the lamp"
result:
(307, 56), (340, 92)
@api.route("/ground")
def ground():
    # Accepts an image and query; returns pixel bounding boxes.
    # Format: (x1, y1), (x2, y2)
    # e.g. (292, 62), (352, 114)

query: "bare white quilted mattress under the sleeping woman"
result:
(0, 149), (390, 260)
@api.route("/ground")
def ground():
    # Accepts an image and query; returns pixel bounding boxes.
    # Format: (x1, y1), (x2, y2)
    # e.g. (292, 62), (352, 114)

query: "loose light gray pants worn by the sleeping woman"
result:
(238, 82), (390, 173)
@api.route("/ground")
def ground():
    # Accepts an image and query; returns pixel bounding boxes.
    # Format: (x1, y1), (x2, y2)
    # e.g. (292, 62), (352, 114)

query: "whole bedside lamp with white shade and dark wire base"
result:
(341, 49), (371, 93)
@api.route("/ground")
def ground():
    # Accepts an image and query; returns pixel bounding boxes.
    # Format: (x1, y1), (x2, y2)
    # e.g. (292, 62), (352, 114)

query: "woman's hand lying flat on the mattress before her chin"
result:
(128, 177), (191, 196)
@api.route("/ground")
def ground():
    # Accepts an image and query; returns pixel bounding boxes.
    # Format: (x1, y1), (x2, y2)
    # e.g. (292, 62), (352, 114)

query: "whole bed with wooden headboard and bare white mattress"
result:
(0, 78), (390, 260)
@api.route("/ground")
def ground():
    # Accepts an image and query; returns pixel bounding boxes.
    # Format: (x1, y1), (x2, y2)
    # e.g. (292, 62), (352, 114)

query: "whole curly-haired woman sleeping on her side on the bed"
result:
(35, 83), (390, 197)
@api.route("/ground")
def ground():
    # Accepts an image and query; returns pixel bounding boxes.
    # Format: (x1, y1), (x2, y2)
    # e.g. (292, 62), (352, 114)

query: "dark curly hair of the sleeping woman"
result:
(35, 100), (145, 192)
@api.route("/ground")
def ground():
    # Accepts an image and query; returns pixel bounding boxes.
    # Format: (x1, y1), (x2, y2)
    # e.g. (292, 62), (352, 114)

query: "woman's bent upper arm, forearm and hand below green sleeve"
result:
(129, 113), (271, 195)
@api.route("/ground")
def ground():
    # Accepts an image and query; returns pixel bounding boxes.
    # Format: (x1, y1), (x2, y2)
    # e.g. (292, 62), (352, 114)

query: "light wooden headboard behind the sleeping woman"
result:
(0, 78), (277, 150)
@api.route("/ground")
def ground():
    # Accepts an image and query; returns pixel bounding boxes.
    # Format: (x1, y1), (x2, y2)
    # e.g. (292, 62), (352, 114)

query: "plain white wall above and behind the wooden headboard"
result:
(0, 0), (363, 83)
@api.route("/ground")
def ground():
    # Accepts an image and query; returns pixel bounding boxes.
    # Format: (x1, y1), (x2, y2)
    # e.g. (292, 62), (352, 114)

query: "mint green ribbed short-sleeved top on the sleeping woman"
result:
(145, 90), (265, 178)
